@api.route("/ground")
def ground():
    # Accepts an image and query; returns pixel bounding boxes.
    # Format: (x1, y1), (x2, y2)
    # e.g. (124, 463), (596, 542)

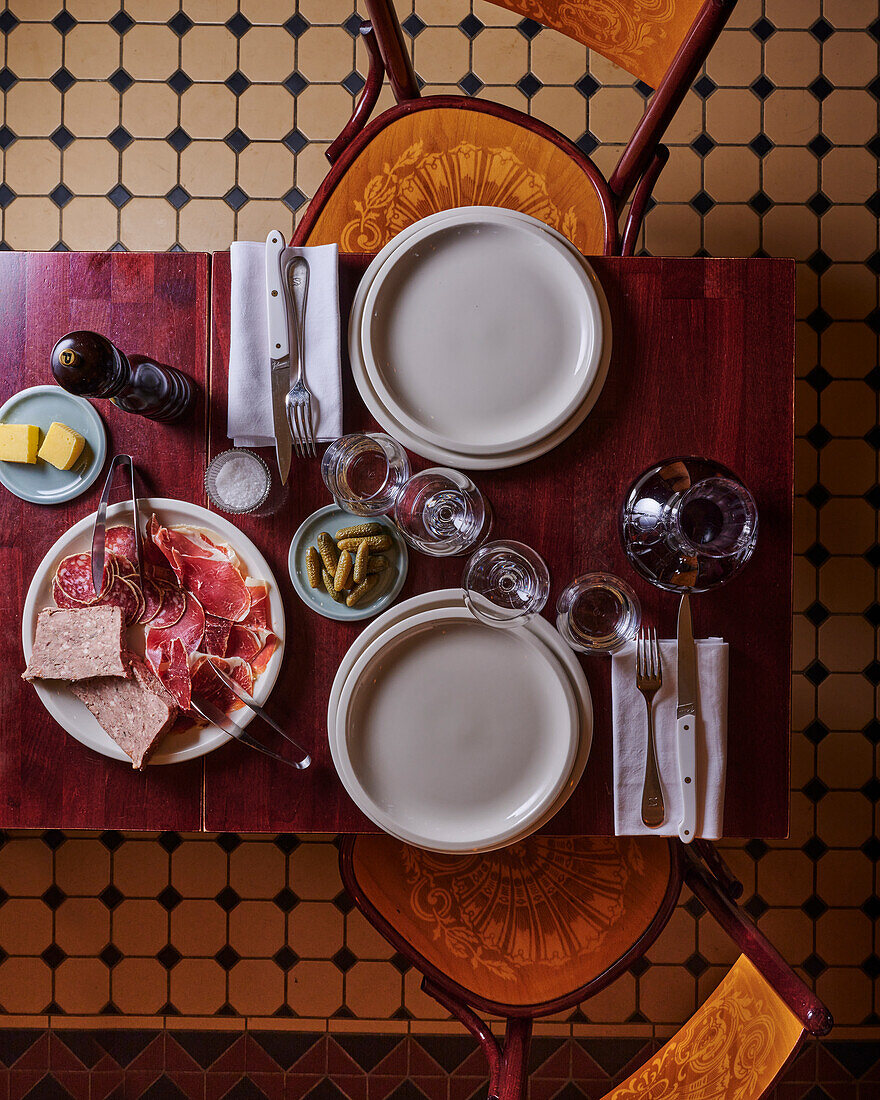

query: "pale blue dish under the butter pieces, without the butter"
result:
(0, 386), (107, 504)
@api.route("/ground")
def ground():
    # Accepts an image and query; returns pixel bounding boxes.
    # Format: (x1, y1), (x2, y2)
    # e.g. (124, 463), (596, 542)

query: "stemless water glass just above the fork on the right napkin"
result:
(557, 573), (641, 653)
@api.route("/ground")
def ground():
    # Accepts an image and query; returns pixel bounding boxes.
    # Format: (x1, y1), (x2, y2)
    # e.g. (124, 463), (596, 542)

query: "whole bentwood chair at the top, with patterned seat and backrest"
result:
(295, 0), (736, 255)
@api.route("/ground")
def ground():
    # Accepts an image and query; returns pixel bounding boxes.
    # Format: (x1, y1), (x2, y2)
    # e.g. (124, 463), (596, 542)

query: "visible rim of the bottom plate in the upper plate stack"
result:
(349, 207), (612, 470)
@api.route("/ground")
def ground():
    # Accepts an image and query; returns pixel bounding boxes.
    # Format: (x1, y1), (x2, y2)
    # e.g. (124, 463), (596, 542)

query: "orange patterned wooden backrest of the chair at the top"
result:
(490, 0), (704, 88)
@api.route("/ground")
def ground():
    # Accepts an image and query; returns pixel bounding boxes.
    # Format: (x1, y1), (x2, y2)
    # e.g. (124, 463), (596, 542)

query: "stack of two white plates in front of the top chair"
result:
(349, 207), (611, 470)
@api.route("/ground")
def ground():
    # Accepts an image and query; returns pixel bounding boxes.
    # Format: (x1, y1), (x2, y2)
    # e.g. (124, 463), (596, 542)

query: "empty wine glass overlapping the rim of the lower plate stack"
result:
(461, 539), (550, 627)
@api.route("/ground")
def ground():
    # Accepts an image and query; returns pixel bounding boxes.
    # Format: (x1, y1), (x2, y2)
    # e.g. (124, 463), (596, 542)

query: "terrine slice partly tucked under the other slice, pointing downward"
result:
(70, 658), (177, 769)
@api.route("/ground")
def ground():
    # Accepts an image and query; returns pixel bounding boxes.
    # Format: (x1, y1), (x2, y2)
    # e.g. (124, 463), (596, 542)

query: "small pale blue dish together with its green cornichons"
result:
(287, 504), (409, 622)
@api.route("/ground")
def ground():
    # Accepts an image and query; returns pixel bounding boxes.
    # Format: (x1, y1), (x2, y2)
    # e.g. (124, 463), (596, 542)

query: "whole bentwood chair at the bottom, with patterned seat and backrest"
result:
(340, 835), (832, 1100)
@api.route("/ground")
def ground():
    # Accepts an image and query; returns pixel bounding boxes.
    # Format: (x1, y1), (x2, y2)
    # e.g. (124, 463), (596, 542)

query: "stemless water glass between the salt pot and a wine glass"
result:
(321, 432), (409, 516)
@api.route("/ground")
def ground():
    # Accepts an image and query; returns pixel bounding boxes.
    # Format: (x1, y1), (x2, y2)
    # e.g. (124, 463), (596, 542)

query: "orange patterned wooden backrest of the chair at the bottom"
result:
(605, 955), (805, 1100)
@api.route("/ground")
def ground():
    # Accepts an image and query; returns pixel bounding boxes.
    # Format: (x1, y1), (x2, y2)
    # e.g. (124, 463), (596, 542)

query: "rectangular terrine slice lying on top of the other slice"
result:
(23, 605), (129, 680)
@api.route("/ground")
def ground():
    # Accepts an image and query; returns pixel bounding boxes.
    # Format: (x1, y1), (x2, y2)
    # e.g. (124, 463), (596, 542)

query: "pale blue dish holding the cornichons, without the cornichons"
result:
(287, 504), (409, 623)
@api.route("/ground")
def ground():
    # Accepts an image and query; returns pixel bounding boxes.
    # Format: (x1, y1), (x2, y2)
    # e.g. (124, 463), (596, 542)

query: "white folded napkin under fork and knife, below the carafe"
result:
(612, 638), (727, 840)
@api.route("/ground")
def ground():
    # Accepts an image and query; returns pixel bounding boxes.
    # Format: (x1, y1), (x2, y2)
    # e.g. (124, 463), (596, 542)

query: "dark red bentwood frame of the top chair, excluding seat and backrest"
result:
(295, 0), (737, 255)
